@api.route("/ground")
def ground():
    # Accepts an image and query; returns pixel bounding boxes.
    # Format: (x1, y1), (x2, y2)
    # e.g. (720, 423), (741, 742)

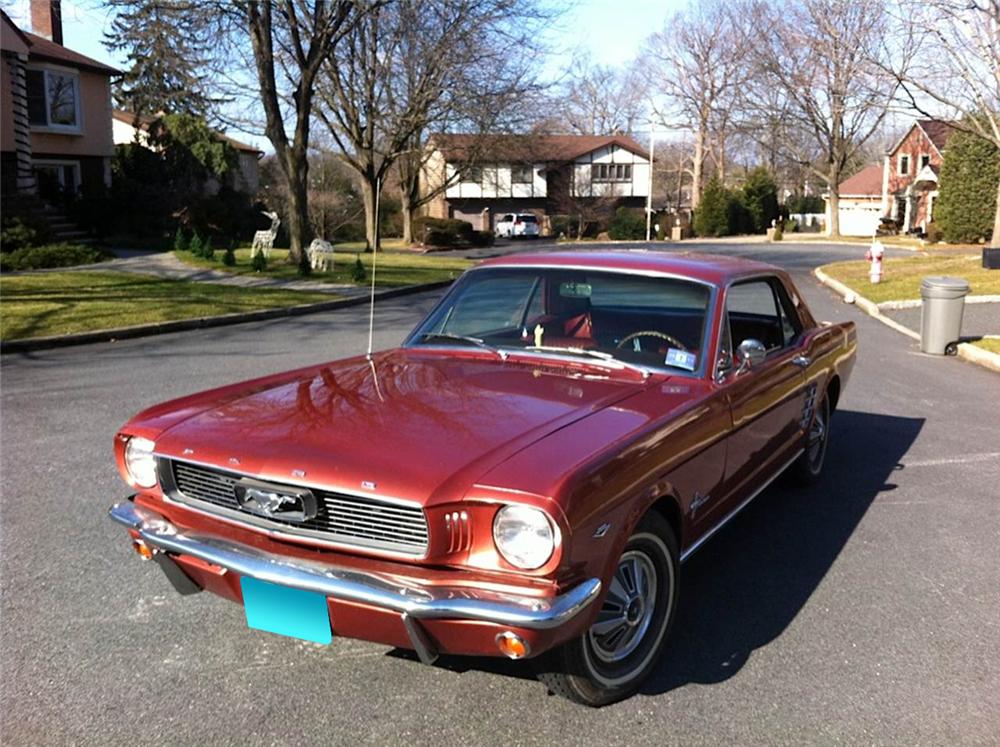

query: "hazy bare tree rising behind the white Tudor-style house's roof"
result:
(554, 52), (647, 135)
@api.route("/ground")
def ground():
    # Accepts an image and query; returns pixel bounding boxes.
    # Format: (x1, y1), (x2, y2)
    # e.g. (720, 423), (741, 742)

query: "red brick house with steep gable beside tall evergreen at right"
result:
(882, 119), (954, 233)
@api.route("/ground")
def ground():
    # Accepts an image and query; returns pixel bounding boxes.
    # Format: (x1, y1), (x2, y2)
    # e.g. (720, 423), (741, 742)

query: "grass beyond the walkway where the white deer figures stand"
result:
(174, 244), (473, 288)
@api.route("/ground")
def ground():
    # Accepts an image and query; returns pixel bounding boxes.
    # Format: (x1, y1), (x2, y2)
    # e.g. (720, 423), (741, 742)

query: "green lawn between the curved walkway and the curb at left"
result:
(0, 272), (336, 340)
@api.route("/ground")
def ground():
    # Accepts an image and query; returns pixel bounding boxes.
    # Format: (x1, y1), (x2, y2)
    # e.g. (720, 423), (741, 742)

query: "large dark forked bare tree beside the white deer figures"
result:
(213, 0), (368, 265)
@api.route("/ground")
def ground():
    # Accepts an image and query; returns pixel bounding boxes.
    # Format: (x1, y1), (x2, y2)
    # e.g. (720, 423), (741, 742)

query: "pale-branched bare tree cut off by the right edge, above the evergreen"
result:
(877, 0), (1000, 247)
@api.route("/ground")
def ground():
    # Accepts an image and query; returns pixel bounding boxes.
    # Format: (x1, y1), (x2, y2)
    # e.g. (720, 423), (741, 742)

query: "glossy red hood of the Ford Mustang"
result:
(146, 349), (646, 505)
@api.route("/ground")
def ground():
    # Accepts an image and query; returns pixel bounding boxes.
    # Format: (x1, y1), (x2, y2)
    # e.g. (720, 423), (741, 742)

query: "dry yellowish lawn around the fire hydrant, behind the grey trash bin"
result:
(821, 253), (1000, 303)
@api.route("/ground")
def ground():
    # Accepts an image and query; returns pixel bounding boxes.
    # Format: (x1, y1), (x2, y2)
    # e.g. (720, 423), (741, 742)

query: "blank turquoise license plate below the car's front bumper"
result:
(240, 576), (333, 643)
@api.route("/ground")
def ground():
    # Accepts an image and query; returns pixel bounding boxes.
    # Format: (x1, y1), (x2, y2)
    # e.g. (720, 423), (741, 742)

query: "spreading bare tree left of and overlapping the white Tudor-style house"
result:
(318, 0), (541, 247)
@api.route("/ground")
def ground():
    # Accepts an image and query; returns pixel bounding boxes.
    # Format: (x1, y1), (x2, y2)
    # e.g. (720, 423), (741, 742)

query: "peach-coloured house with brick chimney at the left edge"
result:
(0, 0), (119, 197)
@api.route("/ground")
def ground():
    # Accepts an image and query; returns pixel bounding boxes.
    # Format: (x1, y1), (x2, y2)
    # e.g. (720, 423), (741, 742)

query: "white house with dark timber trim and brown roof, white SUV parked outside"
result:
(421, 134), (650, 231)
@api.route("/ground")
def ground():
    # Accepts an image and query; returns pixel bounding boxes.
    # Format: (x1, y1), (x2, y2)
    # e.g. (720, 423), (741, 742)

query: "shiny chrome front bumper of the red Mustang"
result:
(109, 501), (601, 630)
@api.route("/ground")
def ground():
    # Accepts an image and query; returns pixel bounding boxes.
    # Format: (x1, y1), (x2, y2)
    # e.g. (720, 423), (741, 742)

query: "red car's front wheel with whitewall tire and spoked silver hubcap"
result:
(535, 512), (680, 707)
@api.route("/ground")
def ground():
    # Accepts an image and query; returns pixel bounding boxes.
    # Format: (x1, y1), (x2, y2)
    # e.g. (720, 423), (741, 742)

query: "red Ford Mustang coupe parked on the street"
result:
(111, 252), (856, 705)
